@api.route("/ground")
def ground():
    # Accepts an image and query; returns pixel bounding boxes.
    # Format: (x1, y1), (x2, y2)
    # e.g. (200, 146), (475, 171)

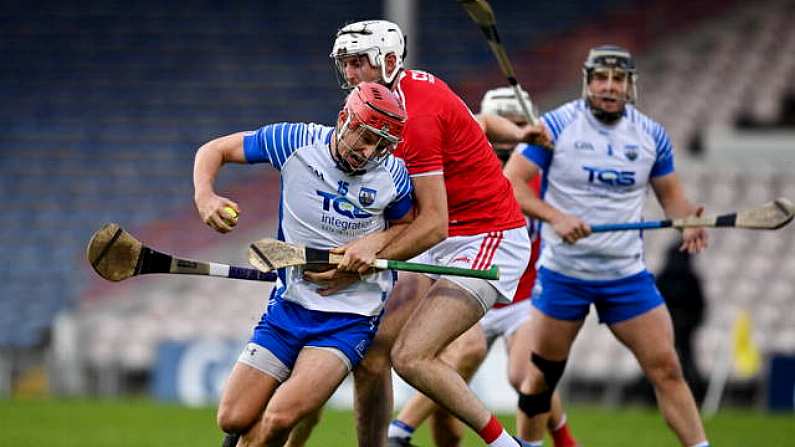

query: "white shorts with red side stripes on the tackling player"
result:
(412, 227), (530, 312)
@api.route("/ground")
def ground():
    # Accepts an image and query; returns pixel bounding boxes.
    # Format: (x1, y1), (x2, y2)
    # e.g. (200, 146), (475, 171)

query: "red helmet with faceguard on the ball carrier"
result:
(337, 82), (406, 171)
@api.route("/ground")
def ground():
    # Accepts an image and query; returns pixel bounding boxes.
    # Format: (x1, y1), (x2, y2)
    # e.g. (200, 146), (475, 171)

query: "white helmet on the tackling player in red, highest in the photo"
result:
(329, 20), (406, 89)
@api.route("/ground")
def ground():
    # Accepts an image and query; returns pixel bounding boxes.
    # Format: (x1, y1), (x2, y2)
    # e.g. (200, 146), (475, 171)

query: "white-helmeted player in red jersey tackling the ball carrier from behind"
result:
(306, 20), (543, 447)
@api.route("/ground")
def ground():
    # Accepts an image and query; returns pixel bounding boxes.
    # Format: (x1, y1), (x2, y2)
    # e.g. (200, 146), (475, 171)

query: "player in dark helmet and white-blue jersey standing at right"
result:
(505, 45), (708, 447)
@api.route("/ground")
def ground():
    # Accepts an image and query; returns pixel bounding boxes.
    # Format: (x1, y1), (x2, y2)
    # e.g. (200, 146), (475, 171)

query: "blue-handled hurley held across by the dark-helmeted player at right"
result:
(591, 197), (795, 233)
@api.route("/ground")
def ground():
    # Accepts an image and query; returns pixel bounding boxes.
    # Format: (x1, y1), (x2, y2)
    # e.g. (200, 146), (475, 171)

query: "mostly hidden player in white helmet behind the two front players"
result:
(387, 87), (577, 447)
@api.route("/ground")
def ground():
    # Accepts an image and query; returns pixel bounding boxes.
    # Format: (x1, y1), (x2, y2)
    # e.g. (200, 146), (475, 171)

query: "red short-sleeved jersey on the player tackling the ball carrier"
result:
(395, 70), (525, 236)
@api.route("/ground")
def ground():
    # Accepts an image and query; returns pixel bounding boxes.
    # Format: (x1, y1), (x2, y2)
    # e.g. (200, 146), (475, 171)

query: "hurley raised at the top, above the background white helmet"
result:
(458, 0), (539, 126)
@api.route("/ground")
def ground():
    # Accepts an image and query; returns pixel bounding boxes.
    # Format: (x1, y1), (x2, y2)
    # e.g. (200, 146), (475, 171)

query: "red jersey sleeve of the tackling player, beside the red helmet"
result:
(400, 115), (444, 176)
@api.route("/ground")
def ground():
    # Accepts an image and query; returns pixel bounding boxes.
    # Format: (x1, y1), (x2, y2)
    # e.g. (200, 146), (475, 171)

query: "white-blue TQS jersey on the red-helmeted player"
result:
(243, 123), (412, 316)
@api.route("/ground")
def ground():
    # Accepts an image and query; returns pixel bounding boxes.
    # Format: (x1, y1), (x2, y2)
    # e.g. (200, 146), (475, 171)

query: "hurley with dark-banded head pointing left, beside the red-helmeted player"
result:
(86, 223), (276, 282)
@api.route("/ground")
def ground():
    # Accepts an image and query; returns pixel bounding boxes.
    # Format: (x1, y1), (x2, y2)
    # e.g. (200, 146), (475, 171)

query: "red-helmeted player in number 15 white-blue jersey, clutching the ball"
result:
(194, 83), (413, 446)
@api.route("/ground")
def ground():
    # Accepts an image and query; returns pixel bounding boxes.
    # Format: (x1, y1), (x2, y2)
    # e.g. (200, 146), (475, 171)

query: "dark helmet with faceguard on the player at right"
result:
(582, 45), (638, 124)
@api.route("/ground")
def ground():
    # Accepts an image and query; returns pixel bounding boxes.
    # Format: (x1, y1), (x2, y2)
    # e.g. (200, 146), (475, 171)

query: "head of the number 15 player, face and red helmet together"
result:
(333, 82), (406, 174)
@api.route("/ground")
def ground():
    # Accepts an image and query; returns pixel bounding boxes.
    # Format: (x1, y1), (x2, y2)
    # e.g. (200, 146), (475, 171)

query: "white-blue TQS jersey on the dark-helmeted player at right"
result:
(521, 99), (674, 280)
